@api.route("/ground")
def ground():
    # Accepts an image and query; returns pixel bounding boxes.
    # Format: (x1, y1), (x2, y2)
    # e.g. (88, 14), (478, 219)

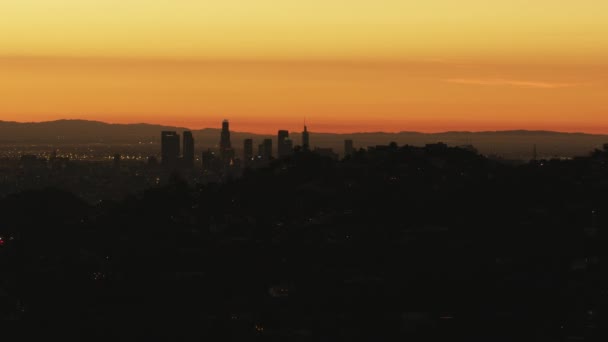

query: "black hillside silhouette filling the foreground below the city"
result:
(0, 144), (608, 341)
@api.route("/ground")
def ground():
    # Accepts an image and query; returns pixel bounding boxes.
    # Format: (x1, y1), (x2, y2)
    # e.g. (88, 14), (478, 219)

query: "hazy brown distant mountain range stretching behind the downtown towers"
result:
(0, 120), (608, 159)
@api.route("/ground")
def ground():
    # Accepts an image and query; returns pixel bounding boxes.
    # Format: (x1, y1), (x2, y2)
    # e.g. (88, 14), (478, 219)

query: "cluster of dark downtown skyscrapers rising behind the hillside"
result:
(161, 120), (354, 174)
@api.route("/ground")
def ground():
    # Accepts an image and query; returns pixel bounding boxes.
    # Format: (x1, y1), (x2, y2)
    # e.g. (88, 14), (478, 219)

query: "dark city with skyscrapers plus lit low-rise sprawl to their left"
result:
(0, 120), (354, 203)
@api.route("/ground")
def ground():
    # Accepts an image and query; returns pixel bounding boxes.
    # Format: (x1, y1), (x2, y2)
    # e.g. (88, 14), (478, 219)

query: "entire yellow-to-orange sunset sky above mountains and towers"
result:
(0, 0), (608, 133)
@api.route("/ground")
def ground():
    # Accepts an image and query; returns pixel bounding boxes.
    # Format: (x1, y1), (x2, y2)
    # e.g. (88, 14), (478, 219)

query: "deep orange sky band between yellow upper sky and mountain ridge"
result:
(0, 57), (608, 133)
